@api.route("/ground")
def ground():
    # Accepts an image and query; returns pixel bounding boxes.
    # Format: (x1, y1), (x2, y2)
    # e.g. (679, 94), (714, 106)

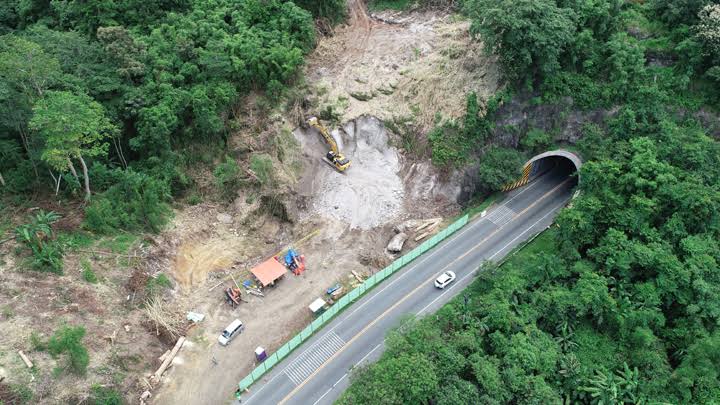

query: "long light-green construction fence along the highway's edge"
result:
(239, 215), (469, 391)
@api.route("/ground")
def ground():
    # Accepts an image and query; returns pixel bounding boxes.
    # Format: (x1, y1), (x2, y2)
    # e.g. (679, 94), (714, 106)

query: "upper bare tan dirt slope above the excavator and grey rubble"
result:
(307, 8), (499, 130)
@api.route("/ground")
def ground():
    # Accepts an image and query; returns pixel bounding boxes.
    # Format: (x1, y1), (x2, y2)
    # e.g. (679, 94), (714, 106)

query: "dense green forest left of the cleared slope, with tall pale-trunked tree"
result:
(0, 0), (345, 221)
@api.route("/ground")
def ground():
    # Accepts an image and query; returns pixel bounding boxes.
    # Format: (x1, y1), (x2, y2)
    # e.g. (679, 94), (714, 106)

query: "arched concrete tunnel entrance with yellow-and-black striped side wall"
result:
(503, 150), (582, 191)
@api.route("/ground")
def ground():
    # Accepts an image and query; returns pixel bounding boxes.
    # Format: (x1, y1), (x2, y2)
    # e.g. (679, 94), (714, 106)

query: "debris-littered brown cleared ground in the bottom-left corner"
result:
(0, 230), (165, 405)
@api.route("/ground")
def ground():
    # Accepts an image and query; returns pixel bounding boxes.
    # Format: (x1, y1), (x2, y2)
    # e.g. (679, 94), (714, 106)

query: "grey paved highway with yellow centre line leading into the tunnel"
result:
(242, 169), (575, 405)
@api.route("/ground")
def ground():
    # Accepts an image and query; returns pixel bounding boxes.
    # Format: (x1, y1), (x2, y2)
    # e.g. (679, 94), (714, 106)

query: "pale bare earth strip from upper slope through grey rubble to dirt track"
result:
(150, 3), (498, 404)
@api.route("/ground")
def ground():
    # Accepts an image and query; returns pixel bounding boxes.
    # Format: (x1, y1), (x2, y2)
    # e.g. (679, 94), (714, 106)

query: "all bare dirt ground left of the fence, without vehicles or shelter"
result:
(0, 5), (498, 404)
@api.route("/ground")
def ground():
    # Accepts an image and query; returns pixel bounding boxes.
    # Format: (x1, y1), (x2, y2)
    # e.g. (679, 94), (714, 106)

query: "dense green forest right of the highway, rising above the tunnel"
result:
(339, 0), (720, 404)
